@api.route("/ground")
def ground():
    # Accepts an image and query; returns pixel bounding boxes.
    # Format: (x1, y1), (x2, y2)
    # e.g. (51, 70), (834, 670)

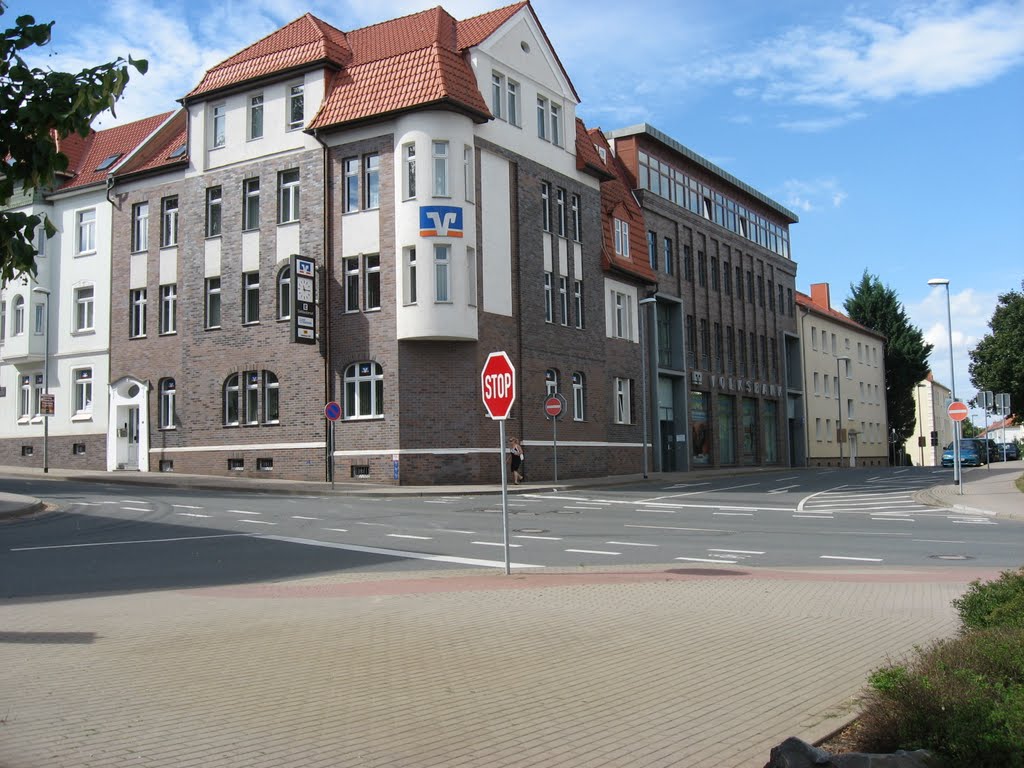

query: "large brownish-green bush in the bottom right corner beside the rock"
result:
(857, 627), (1024, 768)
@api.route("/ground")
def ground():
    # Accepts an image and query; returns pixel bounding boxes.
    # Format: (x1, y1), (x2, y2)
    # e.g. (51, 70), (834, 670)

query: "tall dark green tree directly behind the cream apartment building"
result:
(843, 270), (932, 462)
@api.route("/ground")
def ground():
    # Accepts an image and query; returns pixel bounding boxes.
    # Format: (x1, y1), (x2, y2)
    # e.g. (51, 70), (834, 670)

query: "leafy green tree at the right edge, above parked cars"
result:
(970, 281), (1024, 414)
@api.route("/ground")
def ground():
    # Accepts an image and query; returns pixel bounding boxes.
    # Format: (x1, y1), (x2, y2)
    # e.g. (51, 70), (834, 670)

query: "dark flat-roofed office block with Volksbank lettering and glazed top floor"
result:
(607, 124), (804, 470)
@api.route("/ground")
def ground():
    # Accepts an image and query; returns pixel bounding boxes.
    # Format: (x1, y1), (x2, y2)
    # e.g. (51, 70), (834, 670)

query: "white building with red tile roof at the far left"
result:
(0, 113), (170, 470)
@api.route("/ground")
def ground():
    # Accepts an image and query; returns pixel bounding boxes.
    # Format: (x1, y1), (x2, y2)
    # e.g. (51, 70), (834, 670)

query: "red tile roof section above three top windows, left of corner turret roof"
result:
(185, 13), (352, 100)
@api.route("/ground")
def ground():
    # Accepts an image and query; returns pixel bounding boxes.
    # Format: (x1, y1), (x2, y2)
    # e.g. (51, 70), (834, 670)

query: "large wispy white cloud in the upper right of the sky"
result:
(703, 0), (1024, 110)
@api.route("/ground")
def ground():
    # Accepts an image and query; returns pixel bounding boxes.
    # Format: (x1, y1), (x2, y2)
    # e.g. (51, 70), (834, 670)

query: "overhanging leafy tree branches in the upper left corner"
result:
(0, 0), (148, 284)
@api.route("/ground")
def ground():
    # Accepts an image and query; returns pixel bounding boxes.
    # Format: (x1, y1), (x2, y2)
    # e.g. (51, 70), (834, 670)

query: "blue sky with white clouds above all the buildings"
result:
(24, 0), (1024, 423)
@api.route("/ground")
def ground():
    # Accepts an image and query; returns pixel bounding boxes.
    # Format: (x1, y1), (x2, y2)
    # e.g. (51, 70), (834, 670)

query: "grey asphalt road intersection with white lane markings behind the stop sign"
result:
(0, 468), (1024, 598)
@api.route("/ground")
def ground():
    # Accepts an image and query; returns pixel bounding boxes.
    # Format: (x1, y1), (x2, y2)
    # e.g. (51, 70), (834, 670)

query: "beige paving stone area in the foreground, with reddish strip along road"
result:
(0, 566), (995, 768)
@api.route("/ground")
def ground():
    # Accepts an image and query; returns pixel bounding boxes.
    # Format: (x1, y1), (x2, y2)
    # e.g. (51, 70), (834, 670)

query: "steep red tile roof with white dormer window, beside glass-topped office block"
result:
(588, 128), (657, 284)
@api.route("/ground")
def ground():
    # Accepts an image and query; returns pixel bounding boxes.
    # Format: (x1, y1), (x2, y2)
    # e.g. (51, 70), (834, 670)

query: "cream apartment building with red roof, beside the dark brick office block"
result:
(797, 283), (889, 467)
